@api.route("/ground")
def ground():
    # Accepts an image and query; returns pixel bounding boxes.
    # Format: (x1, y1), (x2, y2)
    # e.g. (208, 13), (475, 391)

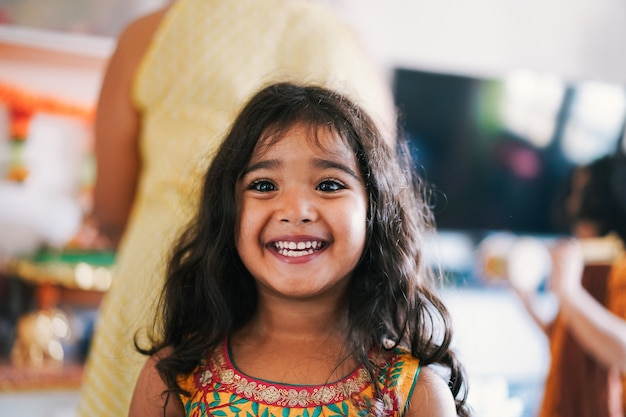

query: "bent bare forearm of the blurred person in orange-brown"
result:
(551, 240), (626, 373)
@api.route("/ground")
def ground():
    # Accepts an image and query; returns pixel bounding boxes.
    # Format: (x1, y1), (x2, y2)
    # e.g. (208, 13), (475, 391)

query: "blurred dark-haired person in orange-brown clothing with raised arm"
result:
(511, 155), (626, 417)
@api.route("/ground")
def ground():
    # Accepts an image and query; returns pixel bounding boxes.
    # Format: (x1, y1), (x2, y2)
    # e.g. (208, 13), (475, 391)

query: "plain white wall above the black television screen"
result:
(328, 0), (626, 84)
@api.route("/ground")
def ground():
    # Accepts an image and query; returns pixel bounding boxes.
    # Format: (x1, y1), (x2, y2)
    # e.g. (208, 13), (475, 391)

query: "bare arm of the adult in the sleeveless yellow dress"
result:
(93, 9), (166, 246)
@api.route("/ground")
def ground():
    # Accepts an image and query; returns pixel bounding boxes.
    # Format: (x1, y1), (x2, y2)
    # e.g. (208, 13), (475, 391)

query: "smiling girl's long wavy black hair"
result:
(138, 83), (470, 416)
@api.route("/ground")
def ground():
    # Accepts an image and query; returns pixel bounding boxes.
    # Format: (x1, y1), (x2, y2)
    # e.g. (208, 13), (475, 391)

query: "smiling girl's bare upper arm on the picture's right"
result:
(405, 366), (457, 417)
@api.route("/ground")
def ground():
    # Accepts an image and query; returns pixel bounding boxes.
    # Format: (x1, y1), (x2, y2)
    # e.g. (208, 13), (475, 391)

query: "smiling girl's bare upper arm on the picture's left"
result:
(128, 355), (185, 417)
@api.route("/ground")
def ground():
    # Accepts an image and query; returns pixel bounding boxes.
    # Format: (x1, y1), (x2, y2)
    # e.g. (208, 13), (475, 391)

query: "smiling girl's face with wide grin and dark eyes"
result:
(236, 125), (367, 298)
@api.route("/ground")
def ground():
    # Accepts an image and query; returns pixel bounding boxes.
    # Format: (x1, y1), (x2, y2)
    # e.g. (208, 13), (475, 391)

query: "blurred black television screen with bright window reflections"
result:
(394, 68), (626, 234)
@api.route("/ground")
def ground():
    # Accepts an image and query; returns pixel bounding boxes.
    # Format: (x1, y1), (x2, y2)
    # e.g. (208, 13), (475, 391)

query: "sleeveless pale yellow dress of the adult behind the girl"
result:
(78, 0), (393, 417)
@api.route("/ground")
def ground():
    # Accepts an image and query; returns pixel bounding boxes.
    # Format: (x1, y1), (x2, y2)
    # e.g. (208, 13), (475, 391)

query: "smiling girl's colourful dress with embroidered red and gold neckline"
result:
(179, 342), (420, 417)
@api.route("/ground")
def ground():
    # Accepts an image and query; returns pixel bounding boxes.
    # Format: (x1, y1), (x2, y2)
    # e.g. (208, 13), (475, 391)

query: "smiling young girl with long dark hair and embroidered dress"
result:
(130, 83), (469, 417)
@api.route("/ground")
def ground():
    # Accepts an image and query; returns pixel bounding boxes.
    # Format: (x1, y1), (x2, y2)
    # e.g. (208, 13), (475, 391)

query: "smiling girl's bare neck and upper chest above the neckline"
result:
(230, 292), (356, 385)
